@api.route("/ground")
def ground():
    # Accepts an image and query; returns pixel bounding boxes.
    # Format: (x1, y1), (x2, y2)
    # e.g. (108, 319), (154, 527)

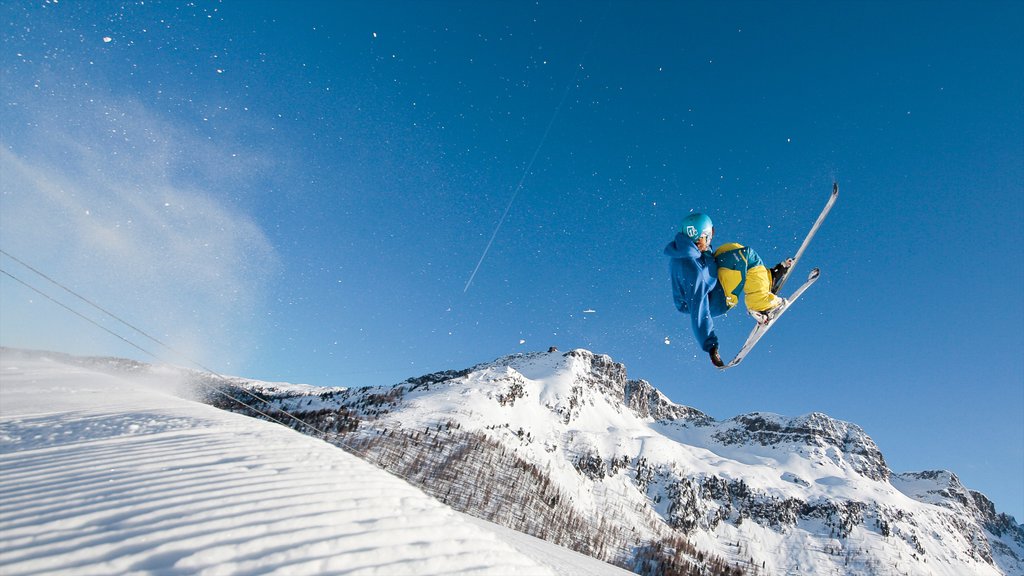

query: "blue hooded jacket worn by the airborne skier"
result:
(665, 233), (728, 352)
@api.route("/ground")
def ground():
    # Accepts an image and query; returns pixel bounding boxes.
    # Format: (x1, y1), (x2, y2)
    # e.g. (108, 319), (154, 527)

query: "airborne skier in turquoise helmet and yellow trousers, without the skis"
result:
(665, 213), (793, 368)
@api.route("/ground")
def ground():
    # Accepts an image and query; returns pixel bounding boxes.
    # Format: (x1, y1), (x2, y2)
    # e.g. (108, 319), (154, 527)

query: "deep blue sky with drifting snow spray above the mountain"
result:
(0, 1), (1024, 521)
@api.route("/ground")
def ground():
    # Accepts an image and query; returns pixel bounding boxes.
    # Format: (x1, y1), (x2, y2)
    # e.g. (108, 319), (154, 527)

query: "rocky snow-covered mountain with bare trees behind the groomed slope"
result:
(202, 349), (1024, 576)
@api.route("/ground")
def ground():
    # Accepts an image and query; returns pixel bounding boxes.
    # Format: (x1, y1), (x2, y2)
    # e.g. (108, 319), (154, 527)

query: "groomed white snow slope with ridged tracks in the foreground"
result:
(0, 351), (628, 576)
